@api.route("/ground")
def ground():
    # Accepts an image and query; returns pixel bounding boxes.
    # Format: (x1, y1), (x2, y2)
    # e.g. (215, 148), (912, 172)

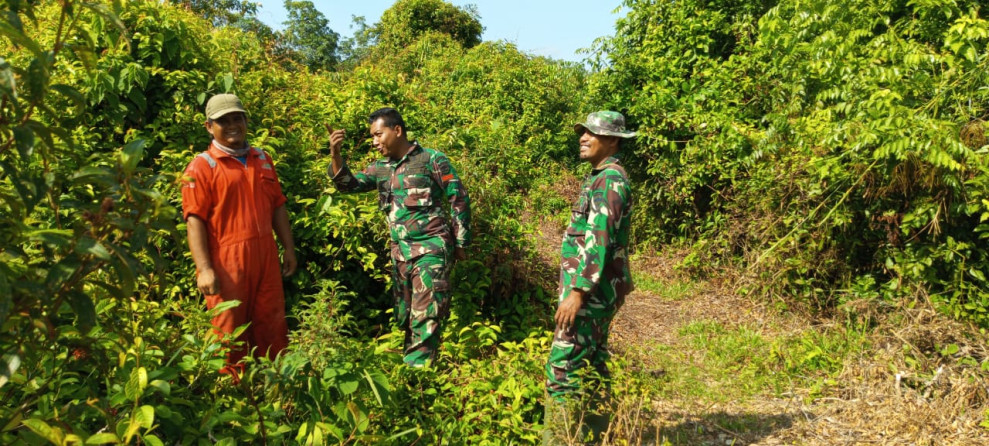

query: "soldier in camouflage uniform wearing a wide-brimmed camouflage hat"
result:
(546, 111), (635, 442)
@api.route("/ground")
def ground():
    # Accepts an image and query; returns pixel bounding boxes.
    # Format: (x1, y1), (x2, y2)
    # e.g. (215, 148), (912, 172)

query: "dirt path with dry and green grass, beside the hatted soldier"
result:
(539, 220), (989, 445)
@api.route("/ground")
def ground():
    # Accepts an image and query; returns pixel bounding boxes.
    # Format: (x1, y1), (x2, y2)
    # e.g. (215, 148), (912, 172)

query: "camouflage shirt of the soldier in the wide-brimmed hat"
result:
(560, 157), (632, 318)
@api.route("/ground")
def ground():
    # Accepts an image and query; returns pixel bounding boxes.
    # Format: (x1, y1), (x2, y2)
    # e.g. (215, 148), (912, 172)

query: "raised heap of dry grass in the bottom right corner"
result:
(780, 306), (989, 445)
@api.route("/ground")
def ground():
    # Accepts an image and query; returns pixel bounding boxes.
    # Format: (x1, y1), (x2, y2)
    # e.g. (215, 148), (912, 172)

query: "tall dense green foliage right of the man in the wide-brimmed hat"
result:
(592, 1), (989, 324)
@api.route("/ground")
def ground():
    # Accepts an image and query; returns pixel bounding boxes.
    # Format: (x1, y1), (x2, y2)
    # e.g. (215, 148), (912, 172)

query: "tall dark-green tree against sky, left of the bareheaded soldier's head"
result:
(282, 0), (340, 71)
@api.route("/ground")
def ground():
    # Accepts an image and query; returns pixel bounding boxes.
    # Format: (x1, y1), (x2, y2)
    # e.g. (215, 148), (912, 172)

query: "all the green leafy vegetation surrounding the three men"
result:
(0, 0), (989, 444)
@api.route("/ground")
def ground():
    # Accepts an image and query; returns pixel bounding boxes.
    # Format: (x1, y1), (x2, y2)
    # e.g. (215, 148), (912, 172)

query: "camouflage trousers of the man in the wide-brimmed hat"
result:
(546, 310), (613, 400)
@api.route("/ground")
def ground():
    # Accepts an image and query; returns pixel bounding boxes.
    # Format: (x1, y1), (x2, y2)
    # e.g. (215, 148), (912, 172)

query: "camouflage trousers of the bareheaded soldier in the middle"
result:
(392, 253), (450, 367)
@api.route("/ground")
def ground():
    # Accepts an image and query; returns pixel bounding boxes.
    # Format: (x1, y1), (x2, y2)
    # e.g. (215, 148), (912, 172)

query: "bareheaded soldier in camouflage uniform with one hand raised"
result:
(327, 108), (471, 367)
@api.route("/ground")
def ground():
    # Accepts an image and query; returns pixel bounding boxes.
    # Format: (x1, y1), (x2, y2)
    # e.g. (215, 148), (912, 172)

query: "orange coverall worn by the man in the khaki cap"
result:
(182, 144), (288, 365)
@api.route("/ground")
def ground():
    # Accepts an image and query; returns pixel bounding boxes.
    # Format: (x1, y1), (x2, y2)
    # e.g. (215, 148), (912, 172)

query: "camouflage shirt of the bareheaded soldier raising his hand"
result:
(329, 144), (471, 261)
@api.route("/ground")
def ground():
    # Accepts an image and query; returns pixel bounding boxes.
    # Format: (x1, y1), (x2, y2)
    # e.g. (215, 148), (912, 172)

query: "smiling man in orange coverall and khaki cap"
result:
(182, 94), (297, 379)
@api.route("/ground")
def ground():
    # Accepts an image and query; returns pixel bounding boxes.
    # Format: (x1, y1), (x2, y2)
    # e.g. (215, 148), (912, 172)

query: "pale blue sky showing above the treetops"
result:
(258, 0), (624, 62)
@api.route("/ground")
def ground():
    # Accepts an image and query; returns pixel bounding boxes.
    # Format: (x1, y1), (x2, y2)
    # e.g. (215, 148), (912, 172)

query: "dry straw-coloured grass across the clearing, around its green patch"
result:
(610, 249), (989, 445)
